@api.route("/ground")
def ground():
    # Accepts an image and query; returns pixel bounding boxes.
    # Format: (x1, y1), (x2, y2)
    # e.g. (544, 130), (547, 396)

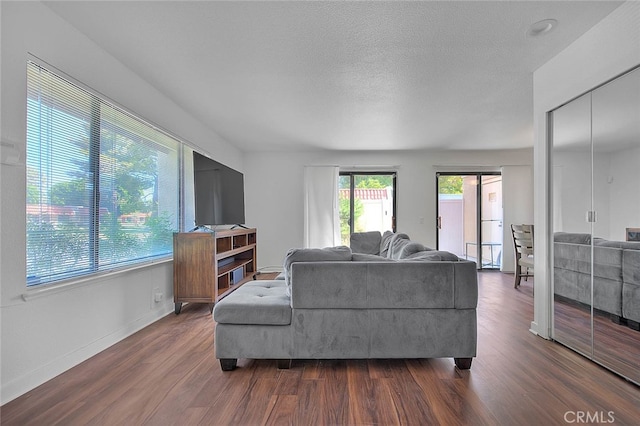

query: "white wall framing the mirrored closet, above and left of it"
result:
(531, 1), (640, 338)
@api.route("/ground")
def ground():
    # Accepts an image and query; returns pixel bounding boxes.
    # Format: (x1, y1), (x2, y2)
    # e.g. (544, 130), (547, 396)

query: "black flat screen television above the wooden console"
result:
(193, 151), (244, 227)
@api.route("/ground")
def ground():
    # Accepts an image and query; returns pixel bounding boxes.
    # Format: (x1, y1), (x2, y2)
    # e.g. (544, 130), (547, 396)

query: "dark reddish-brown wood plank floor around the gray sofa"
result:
(1, 272), (640, 425)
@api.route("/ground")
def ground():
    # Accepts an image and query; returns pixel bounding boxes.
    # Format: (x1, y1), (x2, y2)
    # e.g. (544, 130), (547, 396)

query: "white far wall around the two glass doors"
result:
(245, 150), (532, 267)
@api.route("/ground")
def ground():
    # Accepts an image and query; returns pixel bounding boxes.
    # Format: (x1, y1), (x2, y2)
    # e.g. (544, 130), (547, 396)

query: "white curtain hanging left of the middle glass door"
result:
(303, 166), (340, 248)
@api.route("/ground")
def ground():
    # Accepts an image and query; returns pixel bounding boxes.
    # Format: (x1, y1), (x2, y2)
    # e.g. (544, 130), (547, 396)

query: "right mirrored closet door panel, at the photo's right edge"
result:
(592, 70), (640, 382)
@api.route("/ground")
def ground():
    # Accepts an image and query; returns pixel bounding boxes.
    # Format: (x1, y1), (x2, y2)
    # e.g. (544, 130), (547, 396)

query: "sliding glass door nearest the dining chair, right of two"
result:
(436, 172), (503, 269)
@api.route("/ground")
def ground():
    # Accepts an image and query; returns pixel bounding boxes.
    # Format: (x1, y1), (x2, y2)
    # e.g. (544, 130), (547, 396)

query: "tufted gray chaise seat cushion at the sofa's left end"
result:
(213, 280), (291, 325)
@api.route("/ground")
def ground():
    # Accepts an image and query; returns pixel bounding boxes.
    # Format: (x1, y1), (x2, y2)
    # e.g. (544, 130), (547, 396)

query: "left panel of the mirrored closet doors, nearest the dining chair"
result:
(551, 94), (593, 356)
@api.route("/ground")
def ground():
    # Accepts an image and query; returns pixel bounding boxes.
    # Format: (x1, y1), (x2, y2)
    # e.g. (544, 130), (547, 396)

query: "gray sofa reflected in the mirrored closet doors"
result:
(553, 232), (640, 329)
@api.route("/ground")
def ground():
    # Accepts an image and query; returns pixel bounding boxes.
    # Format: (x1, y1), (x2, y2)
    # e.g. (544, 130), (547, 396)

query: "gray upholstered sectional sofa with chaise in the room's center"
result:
(213, 233), (478, 370)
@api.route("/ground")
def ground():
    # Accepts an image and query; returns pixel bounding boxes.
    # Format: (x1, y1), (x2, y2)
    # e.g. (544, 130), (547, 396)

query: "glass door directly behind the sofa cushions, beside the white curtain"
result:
(338, 172), (396, 245)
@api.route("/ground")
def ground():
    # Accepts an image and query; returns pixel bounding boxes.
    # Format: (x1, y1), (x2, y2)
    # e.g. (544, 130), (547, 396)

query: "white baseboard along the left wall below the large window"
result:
(0, 302), (174, 405)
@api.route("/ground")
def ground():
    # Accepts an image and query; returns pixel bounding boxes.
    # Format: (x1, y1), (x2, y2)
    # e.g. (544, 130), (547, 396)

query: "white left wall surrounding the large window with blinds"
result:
(0, 2), (243, 403)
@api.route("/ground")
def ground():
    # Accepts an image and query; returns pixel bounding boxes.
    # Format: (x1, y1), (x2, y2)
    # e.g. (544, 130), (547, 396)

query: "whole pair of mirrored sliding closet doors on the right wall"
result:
(551, 65), (640, 383)
